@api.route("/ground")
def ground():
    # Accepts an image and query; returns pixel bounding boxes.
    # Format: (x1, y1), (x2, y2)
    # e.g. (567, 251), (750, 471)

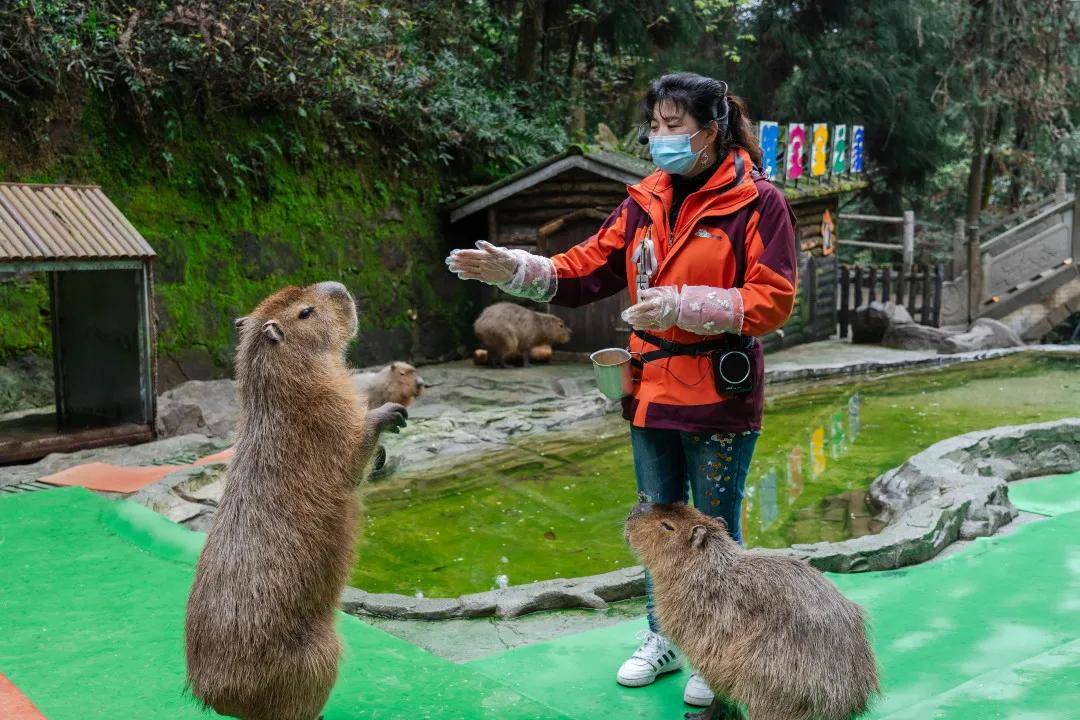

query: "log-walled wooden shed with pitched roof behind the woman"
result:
(449, 147), (866, 352)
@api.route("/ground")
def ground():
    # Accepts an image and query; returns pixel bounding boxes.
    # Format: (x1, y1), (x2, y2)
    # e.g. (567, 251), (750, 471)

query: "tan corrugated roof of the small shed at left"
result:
(0, 182), (154, 262)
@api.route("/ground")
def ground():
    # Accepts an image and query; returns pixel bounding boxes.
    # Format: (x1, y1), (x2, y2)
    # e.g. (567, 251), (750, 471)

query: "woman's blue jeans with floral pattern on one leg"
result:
(630, 425), (760, 631)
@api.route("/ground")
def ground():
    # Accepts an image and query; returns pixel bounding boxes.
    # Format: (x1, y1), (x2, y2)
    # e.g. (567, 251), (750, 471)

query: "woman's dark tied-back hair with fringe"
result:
(640, 72), (761, 167)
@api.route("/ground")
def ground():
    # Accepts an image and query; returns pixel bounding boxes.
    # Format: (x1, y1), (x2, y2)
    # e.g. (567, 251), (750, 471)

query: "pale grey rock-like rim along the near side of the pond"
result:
(341, 418), (1080, 621)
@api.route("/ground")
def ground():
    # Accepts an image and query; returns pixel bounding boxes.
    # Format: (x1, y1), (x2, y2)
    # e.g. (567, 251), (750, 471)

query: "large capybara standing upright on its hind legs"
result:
(186, 282), (406, 720)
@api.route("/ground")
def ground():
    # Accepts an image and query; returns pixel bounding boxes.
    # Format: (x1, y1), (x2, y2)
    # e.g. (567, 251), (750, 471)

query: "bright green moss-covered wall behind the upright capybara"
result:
(0, 111), (469, 369)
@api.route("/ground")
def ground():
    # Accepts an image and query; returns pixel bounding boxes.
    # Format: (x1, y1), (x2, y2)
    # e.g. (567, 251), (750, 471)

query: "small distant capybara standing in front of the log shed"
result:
(473, 302), (570, 367)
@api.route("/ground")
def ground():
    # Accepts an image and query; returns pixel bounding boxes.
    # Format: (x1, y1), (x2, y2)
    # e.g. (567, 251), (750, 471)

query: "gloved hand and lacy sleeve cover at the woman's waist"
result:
(622, 285), (743, 335)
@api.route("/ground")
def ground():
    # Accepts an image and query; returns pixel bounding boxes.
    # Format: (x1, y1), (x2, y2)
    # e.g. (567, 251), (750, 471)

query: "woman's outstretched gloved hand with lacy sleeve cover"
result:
(446, 240), (558, 302)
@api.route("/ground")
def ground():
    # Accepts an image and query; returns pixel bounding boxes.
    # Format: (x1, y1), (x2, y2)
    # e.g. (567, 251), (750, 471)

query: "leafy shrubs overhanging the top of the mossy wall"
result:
(0, 0), (565, 175)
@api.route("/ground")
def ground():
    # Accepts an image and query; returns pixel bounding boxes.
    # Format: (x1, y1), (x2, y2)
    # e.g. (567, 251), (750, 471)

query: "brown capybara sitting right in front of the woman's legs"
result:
(626, 502), (879, 720)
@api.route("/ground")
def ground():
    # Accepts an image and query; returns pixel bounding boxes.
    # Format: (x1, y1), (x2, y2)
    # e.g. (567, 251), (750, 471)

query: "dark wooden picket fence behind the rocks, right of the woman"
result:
(836, 264), (943, 340)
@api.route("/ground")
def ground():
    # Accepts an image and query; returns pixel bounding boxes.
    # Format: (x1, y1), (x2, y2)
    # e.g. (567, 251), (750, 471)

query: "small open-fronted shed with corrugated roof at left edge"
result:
(0, 182), (157, 463)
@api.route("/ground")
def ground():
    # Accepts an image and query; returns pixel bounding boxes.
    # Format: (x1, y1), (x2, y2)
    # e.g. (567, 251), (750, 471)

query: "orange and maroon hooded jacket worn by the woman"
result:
(551, 143), (797, 432)
